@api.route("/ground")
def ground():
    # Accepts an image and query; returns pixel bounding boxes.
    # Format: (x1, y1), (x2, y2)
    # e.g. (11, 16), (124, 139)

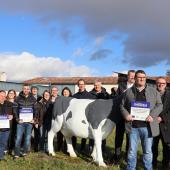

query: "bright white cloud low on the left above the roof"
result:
(0, 52), (93, 81)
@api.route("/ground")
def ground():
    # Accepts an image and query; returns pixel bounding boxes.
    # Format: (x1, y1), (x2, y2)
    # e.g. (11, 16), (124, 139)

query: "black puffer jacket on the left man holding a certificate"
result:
(15, 92), (37, 120)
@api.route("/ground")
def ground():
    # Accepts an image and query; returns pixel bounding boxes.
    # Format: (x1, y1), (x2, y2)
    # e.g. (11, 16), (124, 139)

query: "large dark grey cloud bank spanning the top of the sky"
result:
(0, 0), (170, 67)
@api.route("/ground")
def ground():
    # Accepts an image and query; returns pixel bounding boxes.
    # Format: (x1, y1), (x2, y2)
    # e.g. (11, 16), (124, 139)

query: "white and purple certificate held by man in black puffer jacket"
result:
(19, 108), (33, 122)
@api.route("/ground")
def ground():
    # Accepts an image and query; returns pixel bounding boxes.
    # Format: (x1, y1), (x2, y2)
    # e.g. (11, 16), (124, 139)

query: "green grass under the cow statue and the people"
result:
(0, 131), (162, 170)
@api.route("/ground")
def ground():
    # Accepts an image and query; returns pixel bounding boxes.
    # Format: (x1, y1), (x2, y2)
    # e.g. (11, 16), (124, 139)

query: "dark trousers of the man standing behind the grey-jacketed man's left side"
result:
(115, 118), (129, 156)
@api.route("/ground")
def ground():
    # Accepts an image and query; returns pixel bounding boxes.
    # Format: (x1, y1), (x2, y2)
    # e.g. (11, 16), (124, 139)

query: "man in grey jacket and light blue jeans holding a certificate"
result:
(120, 70), (163, 170)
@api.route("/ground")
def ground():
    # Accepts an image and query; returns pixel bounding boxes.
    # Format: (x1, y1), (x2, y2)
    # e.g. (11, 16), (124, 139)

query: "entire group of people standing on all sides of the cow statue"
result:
(0, 70), (170, 170)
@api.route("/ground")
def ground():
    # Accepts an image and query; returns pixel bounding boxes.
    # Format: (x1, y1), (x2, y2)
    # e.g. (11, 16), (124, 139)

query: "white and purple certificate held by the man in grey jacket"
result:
(130, 101), (150, 121)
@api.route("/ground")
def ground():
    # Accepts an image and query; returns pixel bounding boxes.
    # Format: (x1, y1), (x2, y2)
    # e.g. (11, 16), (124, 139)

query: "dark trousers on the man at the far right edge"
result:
(152, 134), (170, 165)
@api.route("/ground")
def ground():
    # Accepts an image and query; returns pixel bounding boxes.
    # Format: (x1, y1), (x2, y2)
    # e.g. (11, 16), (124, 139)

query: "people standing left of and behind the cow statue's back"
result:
(0, 79), (110, 161)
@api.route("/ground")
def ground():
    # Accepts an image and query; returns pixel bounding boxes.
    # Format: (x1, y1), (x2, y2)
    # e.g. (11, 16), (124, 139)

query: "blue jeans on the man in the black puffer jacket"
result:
(15, 123), (32, 156)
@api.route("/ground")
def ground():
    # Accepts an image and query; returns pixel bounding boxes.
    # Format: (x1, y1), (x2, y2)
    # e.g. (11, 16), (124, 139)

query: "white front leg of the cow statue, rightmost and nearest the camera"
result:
(93, 127), (106, 167)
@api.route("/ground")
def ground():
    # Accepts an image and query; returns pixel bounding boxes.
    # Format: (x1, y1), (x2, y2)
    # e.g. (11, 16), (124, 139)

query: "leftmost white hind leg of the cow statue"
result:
(48, 115), (63, 156)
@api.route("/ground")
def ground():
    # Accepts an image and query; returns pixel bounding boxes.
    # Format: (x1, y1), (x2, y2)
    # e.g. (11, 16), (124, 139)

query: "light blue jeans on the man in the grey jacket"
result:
(126, 127), (153, 170)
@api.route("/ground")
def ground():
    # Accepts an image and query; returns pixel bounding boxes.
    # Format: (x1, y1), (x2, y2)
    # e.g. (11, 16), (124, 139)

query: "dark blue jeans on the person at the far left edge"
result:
(0, 130), (9, 160)
